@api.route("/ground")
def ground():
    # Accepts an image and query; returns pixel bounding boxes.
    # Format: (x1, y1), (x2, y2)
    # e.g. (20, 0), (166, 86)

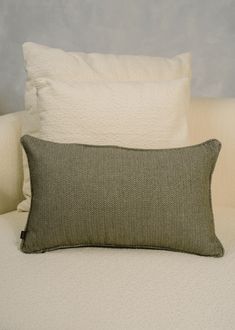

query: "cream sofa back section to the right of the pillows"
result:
(189, 98), (235, 206)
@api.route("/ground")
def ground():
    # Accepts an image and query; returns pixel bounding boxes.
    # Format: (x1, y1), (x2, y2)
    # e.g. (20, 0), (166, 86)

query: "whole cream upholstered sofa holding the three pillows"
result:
(0, 99), (235, 330)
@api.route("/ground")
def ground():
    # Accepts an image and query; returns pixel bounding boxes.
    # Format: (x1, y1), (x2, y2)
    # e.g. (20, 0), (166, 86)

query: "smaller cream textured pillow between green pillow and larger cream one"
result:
(35, 78), (190, 149)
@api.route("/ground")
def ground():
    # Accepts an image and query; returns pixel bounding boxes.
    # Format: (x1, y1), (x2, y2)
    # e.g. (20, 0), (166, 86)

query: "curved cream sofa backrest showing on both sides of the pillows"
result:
(0, 98), (235, 214)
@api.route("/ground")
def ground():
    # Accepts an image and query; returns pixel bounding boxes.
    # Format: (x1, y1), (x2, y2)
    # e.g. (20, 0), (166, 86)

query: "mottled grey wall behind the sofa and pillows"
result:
(0, 0), (235, 114)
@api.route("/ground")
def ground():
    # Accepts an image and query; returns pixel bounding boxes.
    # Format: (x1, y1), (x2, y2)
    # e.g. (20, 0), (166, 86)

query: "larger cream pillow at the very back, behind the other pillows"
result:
(18, 42), (191, 211)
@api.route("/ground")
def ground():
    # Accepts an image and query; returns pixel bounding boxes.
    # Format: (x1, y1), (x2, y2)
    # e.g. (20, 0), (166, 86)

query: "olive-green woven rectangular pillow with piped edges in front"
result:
(21, 136), (223, 257)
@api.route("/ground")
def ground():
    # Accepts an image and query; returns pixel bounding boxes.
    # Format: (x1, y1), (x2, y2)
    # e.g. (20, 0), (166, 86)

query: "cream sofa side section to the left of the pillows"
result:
(0, 112), (23, 214)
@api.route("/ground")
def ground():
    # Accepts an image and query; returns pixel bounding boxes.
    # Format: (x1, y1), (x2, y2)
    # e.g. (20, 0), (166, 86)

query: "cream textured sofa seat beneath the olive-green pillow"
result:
(0, 208), (235, 330)
